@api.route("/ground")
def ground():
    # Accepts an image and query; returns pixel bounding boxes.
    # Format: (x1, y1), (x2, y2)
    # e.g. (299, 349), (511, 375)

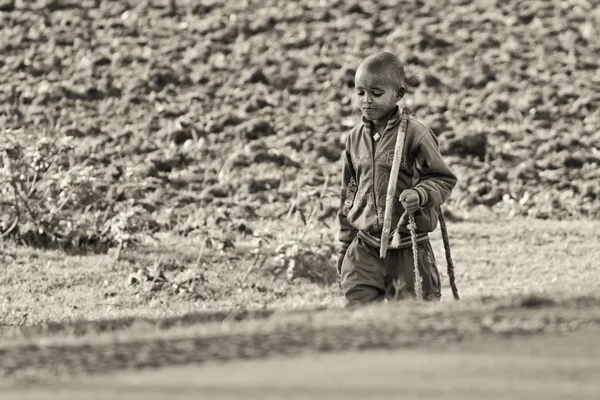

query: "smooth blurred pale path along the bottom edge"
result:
(5, 330), (600, 400)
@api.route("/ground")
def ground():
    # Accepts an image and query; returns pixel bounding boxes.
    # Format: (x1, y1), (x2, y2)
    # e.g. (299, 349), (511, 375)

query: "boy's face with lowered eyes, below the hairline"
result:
(354, 67), (403, 121)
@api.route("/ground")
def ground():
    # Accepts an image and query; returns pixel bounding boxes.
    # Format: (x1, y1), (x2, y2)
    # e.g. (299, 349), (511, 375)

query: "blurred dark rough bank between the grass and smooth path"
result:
(0, 296), (600, 383)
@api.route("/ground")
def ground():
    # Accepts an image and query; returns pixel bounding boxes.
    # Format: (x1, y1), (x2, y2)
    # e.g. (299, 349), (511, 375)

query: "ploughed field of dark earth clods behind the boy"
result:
(0, 0), (600, 248)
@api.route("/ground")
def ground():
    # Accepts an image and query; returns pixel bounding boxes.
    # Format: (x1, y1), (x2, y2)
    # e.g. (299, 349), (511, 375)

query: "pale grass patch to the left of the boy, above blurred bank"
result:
(0, 227), (342, 334)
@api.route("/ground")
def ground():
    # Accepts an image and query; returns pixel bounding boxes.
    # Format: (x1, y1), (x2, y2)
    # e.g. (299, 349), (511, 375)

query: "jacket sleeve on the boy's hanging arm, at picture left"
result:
(338, 142), (358, 254)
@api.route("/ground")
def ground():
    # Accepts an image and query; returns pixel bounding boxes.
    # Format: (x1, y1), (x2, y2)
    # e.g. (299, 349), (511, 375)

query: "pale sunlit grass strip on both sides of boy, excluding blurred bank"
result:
(0, 219), (600, 335)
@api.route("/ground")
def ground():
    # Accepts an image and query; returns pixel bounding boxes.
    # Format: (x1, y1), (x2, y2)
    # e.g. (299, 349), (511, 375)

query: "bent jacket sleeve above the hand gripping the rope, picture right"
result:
(415, 130), (457, 208)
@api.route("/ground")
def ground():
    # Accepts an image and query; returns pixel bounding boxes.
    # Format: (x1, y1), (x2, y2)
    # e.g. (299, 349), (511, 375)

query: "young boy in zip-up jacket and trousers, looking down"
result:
(338, 52), (456, 305)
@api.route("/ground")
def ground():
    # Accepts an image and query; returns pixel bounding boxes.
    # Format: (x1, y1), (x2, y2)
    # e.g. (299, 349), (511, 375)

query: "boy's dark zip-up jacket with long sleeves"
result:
(338, 109), (457, 253)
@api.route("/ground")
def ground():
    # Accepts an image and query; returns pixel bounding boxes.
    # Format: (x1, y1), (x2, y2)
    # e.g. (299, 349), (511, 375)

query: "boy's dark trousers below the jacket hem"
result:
(341, 237), (441, 305)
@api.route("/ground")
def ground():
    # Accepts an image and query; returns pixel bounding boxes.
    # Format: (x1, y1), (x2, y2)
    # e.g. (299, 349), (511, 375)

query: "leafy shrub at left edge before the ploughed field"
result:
(0, 130), (142, 252)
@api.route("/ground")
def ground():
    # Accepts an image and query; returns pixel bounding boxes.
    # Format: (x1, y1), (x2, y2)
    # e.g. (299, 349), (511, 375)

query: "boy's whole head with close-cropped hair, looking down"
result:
(354, 52), (405, 121)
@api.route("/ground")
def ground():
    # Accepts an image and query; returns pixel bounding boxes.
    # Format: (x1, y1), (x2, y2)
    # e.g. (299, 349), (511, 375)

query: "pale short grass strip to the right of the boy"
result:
(433, 219), (600, 301)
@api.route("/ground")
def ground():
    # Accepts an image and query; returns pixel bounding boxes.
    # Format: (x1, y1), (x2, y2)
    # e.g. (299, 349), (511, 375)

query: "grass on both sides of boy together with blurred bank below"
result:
(0, 219), (600, 381)
